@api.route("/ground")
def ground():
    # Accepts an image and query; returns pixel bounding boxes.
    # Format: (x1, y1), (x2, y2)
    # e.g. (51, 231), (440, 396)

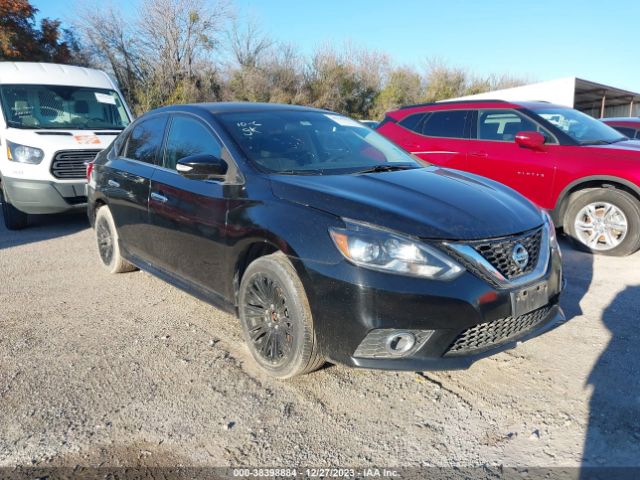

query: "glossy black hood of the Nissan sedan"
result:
(272, 167), (543, 240)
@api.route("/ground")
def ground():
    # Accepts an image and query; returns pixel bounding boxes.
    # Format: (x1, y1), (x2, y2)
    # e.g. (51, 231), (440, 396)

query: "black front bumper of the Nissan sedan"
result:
(301, 246), (565, 371)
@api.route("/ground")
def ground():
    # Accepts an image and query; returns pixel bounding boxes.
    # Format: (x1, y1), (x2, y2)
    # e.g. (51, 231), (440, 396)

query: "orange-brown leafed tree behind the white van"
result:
(0, 0), (87, 65)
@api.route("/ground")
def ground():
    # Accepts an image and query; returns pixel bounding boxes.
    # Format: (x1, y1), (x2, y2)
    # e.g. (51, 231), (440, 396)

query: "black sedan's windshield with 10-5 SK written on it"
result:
(219, 110), (423, 175)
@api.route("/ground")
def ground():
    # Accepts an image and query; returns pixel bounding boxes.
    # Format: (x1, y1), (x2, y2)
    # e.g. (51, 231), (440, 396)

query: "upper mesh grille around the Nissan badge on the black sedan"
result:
(472, 228), (543, 280)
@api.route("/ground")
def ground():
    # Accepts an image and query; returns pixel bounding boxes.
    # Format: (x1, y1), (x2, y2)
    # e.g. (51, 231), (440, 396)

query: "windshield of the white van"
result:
(0, 85), (129, 130)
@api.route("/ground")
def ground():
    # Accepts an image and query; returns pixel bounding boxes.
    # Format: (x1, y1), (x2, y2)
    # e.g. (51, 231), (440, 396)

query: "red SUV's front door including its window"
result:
(466, 109), (558, 208)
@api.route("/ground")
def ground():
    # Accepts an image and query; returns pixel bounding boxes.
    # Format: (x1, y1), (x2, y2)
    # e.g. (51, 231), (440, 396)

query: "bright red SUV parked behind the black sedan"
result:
(377, 100), (640, 256)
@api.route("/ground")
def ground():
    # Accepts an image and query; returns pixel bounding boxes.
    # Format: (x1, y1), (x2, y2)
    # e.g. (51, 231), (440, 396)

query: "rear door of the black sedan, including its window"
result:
(101, 114), (167, 258)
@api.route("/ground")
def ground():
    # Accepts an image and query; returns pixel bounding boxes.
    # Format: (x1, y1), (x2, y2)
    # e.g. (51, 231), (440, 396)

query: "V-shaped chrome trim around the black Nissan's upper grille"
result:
(443, 222), (551, 289)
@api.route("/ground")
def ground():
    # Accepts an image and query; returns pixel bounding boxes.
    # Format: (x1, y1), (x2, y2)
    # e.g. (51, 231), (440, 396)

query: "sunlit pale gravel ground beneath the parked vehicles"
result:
(0, 211), (640, 467)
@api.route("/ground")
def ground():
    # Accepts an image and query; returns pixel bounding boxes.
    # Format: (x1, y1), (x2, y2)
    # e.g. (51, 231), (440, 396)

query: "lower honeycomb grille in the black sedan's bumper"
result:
(445, 305), (551, 356)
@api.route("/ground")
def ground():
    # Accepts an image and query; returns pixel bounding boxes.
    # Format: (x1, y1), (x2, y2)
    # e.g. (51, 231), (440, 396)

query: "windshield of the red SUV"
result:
(535, 107), (626, 145)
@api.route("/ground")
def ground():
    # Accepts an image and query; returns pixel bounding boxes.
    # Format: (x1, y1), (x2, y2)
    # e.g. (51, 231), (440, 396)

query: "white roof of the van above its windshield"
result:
(0, 62), (114, 90)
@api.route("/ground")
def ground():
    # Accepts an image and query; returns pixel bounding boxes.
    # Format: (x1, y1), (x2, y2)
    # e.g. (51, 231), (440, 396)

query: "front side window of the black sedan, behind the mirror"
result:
(164, 115), (222, 170)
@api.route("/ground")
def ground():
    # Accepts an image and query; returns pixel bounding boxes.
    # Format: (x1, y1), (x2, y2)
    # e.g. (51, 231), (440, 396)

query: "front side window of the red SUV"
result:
(477, 110), (554, 142)
